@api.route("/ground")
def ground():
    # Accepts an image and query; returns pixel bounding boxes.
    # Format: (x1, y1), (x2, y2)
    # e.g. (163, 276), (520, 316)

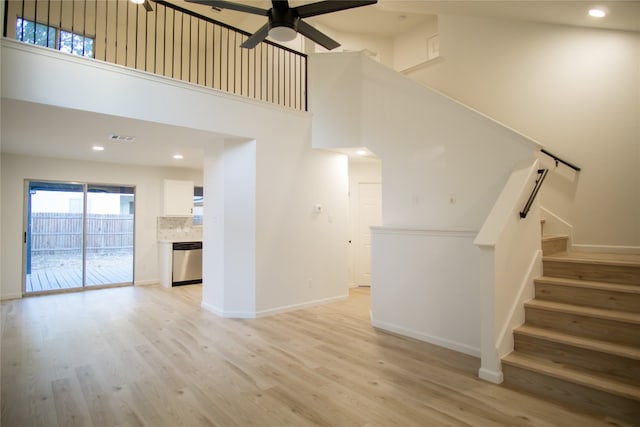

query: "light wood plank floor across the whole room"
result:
(1, 285), (632, 427)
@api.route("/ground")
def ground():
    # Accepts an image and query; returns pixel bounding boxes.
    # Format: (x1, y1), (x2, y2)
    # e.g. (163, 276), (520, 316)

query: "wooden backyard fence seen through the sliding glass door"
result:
(30, 212), (133, 255)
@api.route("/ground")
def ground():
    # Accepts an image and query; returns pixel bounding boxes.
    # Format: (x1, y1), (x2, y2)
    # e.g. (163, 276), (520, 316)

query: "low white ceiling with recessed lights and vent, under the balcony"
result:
(2, 99), (222, 169)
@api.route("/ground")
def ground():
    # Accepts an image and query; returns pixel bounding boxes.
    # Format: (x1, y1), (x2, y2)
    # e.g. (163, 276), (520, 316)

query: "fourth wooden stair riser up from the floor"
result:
(535, 283), (640, 313)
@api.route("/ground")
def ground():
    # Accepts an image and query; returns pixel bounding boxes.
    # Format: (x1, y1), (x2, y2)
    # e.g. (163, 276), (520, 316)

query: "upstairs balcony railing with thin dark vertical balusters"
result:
(3, 0), (307, 110)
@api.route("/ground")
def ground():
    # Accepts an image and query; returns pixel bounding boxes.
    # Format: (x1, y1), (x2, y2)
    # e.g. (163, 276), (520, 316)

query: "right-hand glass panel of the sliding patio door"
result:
(85, 184), (135, 286)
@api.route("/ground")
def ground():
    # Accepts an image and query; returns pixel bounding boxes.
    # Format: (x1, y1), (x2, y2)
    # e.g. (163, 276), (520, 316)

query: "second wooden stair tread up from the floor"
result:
(514, 324), (640, 360)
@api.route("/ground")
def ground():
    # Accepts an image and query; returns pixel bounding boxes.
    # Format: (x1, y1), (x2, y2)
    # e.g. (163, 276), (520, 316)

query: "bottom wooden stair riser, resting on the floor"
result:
(502, 363), (640, 425)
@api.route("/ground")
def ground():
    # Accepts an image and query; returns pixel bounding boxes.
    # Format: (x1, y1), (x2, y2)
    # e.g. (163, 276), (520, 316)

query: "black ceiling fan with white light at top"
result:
(185, 0), (378, 50)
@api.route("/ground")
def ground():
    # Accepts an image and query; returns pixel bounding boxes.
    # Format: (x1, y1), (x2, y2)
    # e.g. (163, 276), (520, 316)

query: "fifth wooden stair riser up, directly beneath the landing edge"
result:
(543, 260), (640, 285)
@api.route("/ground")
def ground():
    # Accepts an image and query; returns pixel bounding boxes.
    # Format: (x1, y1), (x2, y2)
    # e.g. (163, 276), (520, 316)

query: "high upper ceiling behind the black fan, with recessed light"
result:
(174, 0), (640, 37)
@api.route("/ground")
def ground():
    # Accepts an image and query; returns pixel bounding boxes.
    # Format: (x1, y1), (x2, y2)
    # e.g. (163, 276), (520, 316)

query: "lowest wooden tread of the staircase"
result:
(502, 352), (640, 402)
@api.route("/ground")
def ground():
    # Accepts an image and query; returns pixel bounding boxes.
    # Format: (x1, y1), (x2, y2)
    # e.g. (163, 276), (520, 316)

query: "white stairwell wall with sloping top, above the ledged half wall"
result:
(309, 53), (537, 229)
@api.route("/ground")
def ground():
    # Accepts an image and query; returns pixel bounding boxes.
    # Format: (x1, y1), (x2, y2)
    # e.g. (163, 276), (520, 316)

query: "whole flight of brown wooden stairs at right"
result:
(502, 227), (640, 425)
